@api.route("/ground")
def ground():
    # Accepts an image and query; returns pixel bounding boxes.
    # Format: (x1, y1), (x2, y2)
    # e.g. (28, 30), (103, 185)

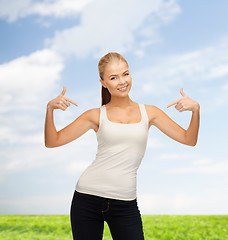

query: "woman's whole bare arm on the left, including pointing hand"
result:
(45, 86), (93, 148)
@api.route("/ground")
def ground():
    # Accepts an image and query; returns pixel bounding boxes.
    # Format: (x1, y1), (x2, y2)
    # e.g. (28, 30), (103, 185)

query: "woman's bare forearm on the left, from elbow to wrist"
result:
(44, 104), (58, 147)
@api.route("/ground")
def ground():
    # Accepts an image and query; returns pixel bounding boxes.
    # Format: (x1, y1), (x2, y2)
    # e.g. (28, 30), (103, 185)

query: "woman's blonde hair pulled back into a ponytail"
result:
(98, 52), (128, 105)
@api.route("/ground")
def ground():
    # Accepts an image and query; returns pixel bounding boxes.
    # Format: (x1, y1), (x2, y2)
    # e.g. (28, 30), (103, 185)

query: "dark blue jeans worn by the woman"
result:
(70, 191), (144, 240)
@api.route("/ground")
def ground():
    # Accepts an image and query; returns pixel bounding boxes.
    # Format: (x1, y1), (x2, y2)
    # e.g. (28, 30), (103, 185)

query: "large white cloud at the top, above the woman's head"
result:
(47, 0), (180, 58)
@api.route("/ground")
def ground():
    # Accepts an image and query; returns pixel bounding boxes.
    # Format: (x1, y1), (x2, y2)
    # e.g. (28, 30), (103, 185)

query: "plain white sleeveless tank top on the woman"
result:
(75, 103), (149, 200)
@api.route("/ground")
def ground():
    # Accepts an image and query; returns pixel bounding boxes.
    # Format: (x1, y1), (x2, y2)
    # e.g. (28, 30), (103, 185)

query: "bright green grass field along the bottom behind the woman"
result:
(0, 215), (228, 240)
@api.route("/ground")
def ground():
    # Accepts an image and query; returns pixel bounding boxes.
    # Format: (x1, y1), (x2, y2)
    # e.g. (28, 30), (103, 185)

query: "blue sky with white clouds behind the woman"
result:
(0, 0), (228, 214)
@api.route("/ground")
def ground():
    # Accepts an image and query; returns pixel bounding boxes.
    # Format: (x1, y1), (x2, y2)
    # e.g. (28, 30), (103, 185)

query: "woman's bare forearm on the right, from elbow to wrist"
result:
(186, 104), (200, 146)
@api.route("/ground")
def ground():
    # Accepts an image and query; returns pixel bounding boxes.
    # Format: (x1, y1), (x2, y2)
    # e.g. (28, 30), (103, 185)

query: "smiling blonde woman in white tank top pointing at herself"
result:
(45, 53), (200, 240)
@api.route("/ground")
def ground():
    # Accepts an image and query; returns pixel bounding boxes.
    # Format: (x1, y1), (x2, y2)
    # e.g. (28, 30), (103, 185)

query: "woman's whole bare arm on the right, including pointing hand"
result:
(150, 90), (200, 146)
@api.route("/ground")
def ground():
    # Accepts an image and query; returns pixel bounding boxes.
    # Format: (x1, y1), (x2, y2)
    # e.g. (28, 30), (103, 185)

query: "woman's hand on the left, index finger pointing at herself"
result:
(47, 86), (78, 111)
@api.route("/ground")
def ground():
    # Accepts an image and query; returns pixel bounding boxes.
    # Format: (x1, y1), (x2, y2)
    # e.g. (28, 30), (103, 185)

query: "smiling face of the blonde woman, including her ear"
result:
(100, 60), (132, 96)
